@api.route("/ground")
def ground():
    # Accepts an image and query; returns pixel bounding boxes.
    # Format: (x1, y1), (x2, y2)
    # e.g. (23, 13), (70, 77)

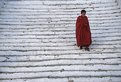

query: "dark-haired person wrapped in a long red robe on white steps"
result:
(76, 10), (92, 51)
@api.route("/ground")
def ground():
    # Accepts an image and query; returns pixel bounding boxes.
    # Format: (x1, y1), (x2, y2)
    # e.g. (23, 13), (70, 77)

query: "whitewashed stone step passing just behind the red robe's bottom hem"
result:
(0, 40), (121, 47)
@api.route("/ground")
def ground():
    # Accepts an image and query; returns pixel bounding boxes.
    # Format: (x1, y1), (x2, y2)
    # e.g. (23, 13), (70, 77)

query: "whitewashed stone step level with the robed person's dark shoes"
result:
(0, 45), (121, 51)
